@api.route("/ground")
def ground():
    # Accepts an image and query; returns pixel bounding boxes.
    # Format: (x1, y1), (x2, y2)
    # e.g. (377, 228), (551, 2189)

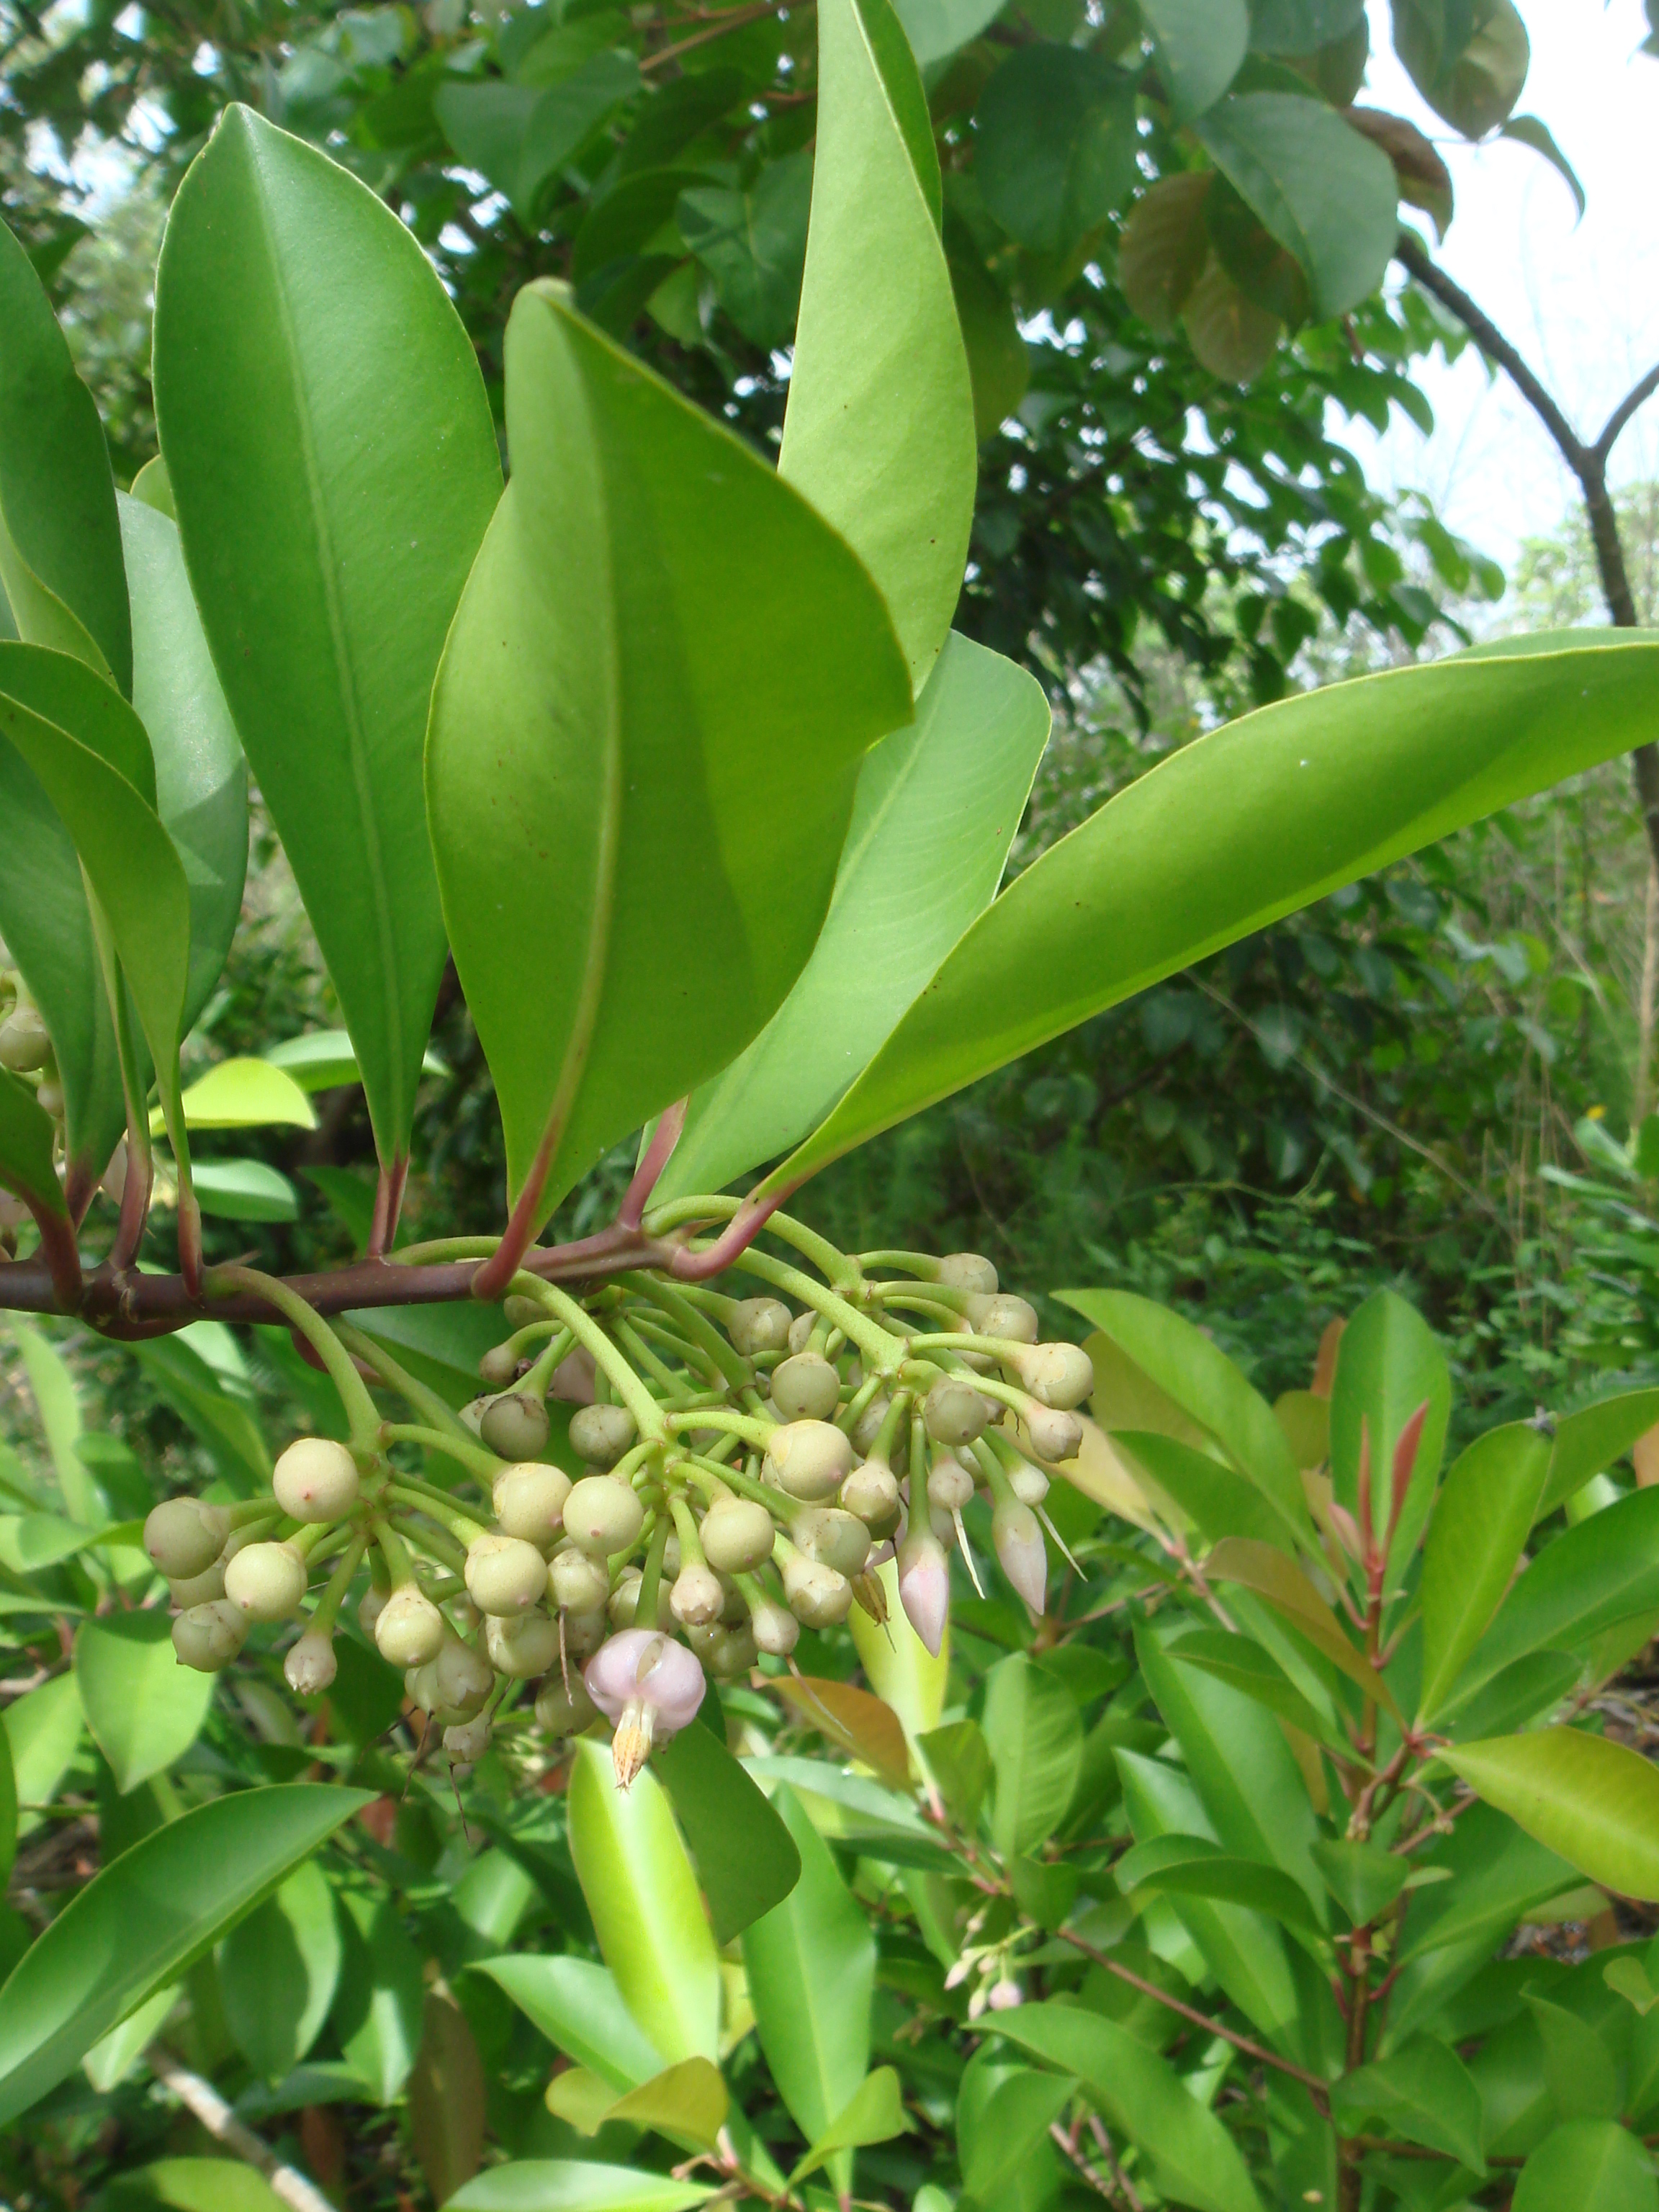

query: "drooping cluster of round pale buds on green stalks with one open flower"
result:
(144, 1217), (1093, 1785)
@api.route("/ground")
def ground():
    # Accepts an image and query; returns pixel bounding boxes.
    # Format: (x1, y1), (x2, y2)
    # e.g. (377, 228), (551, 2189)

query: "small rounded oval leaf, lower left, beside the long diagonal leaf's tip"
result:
(219, 1865), (345, 2082)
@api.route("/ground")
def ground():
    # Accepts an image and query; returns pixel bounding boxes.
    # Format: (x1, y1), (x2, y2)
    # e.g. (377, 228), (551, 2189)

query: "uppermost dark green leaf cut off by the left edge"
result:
(0, 223), (132, 693)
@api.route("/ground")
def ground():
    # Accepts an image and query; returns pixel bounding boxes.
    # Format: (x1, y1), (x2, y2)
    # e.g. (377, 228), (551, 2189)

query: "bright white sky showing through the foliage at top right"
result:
(1343, 0), (1659, 564)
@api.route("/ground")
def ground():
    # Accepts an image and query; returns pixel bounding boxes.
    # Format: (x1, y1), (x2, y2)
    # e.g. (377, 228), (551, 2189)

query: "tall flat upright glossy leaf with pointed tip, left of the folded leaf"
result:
(155, 106), (500, 1161)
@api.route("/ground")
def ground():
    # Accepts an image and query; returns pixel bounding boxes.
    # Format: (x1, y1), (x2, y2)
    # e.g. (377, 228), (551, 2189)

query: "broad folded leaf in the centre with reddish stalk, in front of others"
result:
(427, 285), (909, 1226)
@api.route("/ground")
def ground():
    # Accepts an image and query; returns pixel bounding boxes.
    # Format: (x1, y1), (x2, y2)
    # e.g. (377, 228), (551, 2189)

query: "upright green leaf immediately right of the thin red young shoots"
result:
(1418, 1422), (1550, 1721)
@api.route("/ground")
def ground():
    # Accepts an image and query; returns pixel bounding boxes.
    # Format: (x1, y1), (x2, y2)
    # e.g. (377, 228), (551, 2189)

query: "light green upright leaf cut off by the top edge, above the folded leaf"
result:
(778, 0), (978, 690)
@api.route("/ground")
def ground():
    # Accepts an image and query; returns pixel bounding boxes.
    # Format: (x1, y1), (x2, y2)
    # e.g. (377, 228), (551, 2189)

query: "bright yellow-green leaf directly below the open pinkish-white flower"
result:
(569, 1737), (716, 2070)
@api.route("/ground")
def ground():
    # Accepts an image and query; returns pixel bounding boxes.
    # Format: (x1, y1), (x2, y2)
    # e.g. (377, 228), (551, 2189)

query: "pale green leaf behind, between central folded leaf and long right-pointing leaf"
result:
(657, 633), (1048, 1199)
